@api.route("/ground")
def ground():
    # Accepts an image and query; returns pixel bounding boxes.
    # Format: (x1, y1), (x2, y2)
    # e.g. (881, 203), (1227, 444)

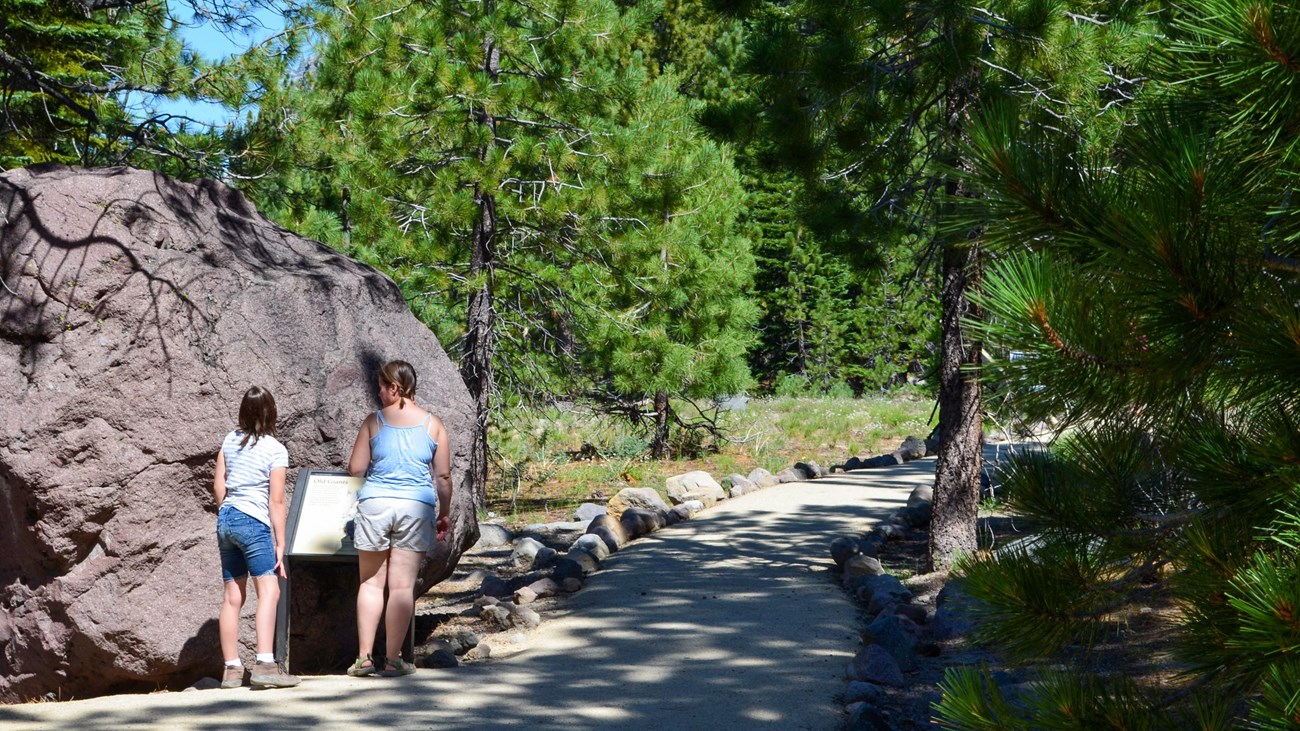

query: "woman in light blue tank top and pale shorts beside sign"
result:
(347, 360), (451, 676)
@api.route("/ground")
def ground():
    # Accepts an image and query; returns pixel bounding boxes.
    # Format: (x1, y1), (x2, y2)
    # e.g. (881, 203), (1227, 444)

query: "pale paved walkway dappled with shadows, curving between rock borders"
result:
(0, 459), (933, 731)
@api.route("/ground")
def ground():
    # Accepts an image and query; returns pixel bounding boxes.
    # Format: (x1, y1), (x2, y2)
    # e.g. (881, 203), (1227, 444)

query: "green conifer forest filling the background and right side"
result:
(0, 0), (1300, 730)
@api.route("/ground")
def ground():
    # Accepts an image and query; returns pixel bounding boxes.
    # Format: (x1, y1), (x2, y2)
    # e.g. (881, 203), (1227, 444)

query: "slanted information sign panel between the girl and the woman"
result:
(285, 470), (365, 559)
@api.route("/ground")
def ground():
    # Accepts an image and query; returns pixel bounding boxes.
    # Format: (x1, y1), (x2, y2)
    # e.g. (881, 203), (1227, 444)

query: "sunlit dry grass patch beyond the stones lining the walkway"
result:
(488, 394), (933, 525)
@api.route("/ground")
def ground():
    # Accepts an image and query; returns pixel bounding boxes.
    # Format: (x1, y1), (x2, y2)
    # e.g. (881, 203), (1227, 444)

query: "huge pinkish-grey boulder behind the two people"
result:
(0, 166), (477, 702)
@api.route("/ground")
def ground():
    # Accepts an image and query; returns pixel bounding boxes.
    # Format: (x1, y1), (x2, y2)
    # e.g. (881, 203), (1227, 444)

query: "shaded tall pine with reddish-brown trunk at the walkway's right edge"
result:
(733, 0), (983, 566)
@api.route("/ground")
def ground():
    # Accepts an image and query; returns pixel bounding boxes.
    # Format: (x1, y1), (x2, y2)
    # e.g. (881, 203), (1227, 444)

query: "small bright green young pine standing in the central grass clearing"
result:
(584, 75), (755, 450)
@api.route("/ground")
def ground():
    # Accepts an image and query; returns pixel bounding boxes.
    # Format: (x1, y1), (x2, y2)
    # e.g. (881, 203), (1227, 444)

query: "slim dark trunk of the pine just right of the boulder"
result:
(460, 39), (501, 510)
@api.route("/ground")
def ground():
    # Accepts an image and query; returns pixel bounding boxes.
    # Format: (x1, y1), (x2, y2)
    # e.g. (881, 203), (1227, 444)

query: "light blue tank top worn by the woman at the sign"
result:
(356, 411), (438, 507)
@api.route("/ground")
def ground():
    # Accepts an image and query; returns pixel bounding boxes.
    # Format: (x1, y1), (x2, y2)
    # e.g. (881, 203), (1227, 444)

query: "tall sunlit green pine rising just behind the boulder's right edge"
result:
(245, 0), (742, 501)
